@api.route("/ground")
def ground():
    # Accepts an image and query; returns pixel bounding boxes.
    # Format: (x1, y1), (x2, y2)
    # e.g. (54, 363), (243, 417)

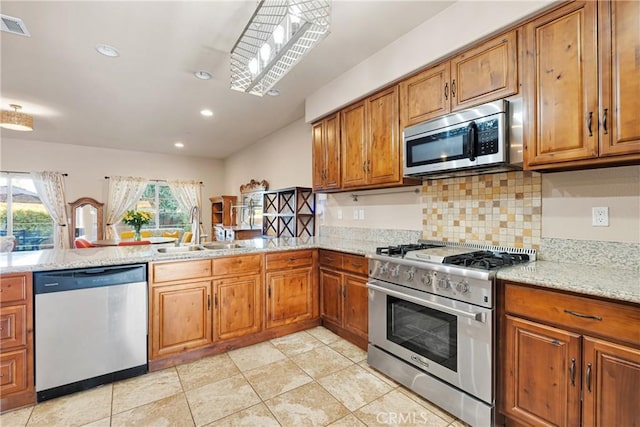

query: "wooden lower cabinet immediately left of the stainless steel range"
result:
(318, 250), (369, 348)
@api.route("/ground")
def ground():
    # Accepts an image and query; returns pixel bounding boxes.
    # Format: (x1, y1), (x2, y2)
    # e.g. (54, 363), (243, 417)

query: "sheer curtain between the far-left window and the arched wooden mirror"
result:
(31, 172), (69, 249)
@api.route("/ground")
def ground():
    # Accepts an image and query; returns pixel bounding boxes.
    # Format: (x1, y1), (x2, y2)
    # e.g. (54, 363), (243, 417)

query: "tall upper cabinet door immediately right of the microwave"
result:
(525, 1), (598, 169)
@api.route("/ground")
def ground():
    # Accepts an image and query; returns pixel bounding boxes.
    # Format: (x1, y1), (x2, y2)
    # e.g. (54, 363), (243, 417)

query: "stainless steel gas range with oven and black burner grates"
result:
(367, 241), (535, 427)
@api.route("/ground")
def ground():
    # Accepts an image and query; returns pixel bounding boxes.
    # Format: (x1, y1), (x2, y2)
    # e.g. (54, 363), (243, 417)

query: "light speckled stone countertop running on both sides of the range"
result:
(0, 237), (640, 304)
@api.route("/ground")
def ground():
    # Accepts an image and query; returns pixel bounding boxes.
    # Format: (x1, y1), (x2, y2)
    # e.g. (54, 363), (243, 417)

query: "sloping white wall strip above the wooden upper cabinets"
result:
(305, 0), (554, 122)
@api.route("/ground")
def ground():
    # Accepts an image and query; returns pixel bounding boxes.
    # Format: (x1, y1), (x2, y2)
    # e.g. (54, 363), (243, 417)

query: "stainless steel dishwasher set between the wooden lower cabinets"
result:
(33, 264), (147, 402)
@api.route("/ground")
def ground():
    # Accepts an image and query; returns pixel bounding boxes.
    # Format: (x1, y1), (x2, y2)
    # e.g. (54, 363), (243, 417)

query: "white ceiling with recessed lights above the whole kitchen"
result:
(0, 0), (452, 159)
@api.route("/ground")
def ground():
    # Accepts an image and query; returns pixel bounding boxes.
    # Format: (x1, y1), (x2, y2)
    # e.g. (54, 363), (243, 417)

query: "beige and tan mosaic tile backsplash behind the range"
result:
(422, 171), (542, 249)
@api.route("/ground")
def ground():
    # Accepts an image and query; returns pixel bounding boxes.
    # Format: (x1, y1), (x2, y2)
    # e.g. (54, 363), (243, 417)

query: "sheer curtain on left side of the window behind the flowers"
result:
(105, 176), (149, 240)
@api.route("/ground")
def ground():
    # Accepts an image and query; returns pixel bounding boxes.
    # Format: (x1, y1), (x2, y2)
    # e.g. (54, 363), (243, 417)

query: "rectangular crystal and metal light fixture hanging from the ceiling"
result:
(231, 0), (331, 96)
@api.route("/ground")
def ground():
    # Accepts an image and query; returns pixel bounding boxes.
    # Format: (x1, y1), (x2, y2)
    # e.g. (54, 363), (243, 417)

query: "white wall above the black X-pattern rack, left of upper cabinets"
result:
(224, 118), (312, 196)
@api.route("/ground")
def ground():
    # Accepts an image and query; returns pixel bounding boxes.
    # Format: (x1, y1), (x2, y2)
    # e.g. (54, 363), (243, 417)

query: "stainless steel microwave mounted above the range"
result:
(403, 100), (522, 178)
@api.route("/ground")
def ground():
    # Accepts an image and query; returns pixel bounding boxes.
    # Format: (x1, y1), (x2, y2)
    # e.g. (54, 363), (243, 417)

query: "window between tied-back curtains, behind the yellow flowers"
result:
(136, 182), (190, 229)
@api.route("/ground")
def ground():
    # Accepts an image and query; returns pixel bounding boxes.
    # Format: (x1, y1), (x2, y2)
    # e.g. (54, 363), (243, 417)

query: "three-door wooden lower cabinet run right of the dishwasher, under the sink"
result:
(149, 250), (320, 371)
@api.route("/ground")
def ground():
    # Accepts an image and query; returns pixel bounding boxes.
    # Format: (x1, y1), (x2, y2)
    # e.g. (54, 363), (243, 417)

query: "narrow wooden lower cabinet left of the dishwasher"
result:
(0, 273), (36, 411)
